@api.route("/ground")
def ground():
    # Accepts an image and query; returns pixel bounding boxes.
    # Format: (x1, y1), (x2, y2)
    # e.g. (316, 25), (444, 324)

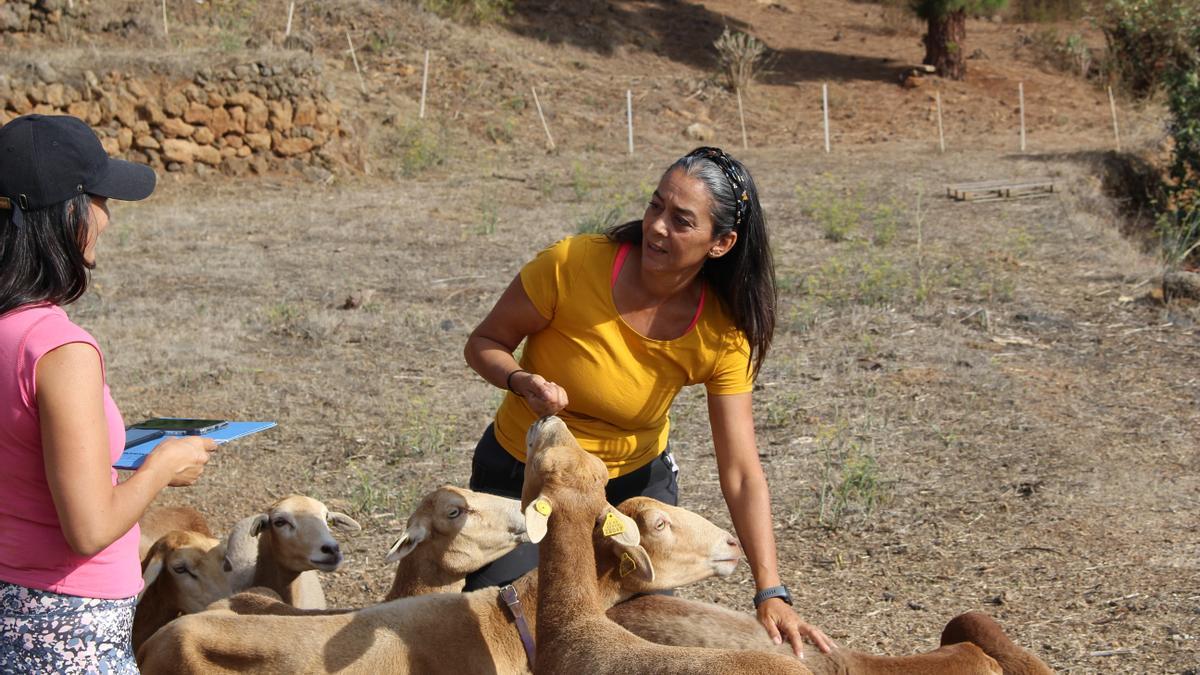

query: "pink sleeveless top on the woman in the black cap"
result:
(0, 304), (142, 599)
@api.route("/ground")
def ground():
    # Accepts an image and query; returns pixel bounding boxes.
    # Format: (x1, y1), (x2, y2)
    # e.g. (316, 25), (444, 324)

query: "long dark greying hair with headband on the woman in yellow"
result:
(605, 148), (778, 377)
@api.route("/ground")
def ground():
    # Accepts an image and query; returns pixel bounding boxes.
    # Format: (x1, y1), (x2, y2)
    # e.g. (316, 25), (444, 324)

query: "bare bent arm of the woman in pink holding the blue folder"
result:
(35, 342), (216, 556)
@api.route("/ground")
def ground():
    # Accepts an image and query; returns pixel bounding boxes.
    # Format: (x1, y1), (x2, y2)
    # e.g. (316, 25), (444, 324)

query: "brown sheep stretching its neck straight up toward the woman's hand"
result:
(521, 417), (1000, 675)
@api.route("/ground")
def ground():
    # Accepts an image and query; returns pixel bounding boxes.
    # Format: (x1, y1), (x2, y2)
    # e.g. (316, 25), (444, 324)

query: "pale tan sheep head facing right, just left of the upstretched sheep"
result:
(386, 485), (529, 575)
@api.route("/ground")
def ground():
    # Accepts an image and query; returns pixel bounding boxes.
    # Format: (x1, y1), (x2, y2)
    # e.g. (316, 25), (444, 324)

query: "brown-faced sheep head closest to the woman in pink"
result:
(139, 530), (233, 614)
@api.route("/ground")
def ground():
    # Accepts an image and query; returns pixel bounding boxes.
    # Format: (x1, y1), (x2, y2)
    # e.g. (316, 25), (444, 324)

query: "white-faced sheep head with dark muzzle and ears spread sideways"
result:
(250, 495), (362, 572)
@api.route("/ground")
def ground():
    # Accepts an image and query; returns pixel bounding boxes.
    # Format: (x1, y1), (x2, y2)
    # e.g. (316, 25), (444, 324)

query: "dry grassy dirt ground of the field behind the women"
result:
(16, 0), (1200, 675)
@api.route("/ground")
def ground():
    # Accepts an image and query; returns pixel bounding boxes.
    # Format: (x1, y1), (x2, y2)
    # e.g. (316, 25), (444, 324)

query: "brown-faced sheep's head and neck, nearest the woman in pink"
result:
(133, 530), (230, 650)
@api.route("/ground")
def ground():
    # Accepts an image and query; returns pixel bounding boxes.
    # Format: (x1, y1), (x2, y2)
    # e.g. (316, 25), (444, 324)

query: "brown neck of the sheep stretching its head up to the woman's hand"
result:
(538, 500), (606, 624)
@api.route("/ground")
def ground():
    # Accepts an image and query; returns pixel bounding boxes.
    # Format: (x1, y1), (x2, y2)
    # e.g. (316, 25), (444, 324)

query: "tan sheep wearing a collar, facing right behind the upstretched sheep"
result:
(138, 492), (740, 675)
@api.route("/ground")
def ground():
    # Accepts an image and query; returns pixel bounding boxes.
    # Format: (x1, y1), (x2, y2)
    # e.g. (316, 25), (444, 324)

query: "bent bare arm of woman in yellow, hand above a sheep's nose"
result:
(463, 275), (568, 416)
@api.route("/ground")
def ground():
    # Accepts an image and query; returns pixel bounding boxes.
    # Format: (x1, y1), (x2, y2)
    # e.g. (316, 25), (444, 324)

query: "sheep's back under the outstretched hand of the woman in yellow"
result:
(606, 596), (1007, 675)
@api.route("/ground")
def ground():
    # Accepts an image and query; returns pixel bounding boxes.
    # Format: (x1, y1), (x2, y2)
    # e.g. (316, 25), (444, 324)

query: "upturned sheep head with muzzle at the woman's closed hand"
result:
(521, 416), (609, 544)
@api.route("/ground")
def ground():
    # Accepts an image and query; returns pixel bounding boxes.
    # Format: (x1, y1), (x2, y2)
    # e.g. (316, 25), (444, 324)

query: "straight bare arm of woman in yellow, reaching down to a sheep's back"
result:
(708, 393), (833, 656)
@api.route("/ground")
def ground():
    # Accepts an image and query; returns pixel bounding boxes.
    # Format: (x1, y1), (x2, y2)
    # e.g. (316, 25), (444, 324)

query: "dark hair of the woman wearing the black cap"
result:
(0, 195), (95, 315)
